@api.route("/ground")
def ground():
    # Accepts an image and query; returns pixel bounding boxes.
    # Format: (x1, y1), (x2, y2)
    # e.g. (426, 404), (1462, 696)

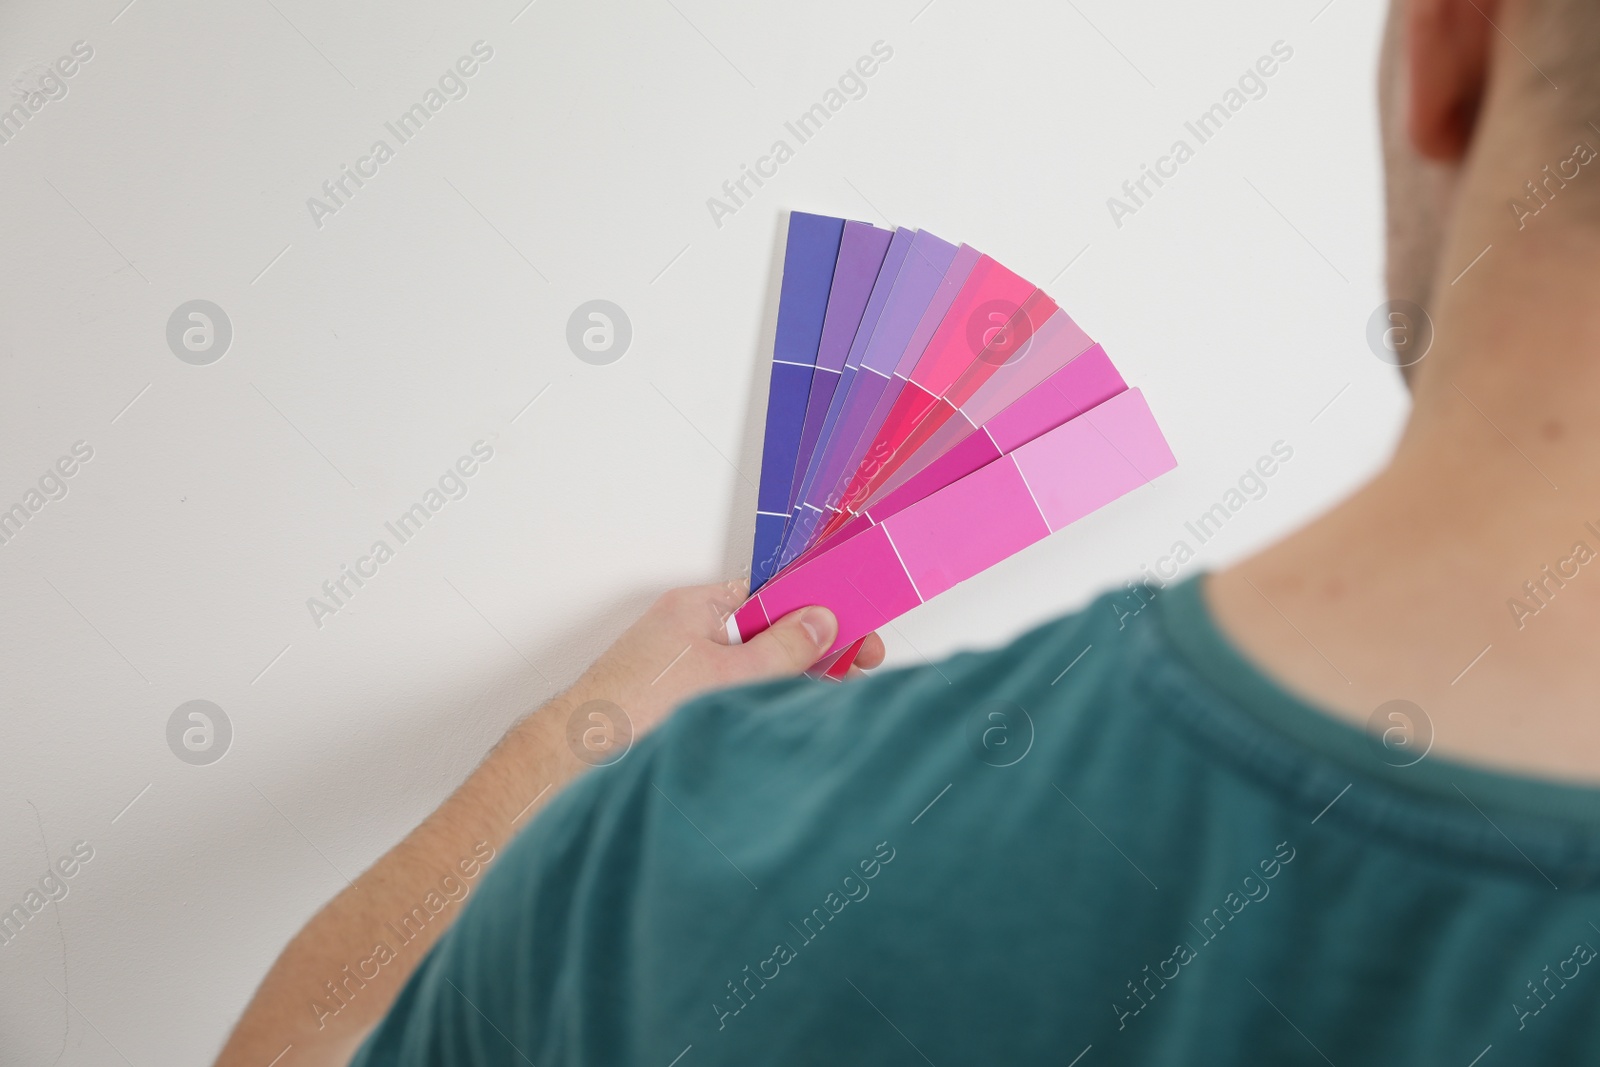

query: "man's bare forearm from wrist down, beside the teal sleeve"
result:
(218, 694), (587, 1067)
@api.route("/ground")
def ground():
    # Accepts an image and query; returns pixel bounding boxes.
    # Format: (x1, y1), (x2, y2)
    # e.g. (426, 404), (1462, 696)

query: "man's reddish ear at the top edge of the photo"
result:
(1405, 0), (1502, 163)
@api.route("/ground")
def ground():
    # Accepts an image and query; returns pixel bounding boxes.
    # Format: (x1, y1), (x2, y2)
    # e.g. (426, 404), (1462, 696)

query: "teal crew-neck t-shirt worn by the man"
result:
(355, 581), (1600, 1067)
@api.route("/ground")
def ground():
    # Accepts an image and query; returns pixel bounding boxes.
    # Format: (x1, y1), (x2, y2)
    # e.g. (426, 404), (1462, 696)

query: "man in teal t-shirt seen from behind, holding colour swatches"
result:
(219, 0), (1600, 1067)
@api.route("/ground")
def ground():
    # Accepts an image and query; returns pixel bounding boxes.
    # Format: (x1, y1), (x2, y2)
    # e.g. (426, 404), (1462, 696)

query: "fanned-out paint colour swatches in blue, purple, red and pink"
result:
(728, 211), (1178, 677)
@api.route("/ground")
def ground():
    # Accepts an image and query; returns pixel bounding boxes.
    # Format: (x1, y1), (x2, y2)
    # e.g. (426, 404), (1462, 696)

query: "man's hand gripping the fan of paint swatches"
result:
(565, 582), (883, 733)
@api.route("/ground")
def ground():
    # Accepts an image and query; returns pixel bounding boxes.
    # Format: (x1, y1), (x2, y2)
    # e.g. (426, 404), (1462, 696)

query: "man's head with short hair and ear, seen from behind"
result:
(1378, 0), (1600, 379)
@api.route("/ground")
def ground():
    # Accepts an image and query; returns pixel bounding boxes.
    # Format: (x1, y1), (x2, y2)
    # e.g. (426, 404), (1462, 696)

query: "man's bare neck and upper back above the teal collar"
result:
(1208, 212), (1600, 782)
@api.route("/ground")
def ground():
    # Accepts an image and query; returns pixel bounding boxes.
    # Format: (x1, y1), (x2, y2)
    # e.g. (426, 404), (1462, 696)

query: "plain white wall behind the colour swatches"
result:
(0, 0), (1405, 1065)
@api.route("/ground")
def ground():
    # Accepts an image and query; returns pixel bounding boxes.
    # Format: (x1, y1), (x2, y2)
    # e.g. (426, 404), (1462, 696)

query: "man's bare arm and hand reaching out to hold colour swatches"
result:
(218, 585), (883, 1067)
